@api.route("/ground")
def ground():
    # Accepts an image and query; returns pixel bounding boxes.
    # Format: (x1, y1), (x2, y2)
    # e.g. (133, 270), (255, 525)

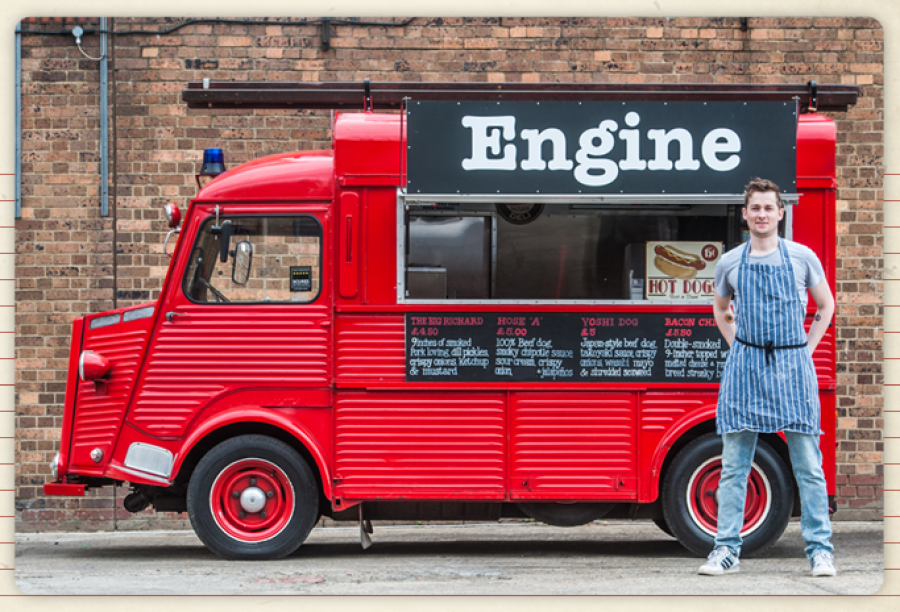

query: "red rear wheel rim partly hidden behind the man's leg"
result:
(687, 456), (772, 537)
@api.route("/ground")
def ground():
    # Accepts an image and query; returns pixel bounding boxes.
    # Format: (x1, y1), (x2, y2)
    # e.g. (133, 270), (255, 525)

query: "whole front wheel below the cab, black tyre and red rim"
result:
(187, 435), (319, 559)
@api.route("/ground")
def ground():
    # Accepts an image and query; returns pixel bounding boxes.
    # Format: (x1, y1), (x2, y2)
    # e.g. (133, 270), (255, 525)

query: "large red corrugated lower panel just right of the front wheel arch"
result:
(335, 392), (506, 499)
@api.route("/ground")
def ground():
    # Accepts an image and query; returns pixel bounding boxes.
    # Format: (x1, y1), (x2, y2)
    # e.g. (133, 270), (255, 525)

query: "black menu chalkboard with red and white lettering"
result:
(406, 312), (728, 383)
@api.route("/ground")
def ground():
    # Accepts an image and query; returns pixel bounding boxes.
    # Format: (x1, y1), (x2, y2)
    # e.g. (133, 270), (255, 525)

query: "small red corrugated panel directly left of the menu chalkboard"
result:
(335, 314), (406, 383)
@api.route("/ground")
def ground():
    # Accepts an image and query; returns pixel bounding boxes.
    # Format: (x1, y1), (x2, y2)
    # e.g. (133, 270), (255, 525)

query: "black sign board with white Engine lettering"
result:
(407, 101), (797, 195)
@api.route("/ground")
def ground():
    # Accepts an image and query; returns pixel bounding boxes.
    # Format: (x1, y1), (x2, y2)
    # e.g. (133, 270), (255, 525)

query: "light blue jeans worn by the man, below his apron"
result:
(716, 430), (834, 557)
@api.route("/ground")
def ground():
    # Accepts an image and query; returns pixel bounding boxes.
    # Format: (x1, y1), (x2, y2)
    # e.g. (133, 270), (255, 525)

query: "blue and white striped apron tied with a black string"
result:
(716, 238), (821, 434)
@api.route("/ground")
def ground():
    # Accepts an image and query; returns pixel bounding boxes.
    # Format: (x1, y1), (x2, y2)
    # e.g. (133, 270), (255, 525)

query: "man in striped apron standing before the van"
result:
(700, 179), (836, 576)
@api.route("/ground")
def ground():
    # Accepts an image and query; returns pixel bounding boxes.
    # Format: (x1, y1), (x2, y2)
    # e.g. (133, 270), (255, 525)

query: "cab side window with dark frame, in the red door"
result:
(182, 215), (322, 304)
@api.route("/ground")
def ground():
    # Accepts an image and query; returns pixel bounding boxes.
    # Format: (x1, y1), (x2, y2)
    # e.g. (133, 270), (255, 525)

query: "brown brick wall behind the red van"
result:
(16, 18), (884, 530)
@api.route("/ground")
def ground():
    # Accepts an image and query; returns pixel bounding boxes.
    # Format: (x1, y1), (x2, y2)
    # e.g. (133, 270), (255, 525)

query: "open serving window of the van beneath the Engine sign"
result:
(398, 197), (790, 303)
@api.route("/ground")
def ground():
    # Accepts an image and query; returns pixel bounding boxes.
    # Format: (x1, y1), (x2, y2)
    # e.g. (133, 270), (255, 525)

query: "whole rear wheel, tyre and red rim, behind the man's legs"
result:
(662, 434), (794, 557)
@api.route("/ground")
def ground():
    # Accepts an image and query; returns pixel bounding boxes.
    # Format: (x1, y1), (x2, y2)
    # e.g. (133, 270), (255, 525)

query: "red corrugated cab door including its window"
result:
(128, 205), (332, 437)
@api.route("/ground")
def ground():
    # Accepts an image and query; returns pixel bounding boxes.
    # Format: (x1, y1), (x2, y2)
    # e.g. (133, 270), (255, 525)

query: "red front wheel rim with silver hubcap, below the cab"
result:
(209, 459), (295, 542)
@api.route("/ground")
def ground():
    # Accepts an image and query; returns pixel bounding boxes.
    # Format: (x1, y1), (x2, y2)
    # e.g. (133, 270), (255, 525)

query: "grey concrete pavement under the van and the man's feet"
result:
(15, 521), (883, 595)
